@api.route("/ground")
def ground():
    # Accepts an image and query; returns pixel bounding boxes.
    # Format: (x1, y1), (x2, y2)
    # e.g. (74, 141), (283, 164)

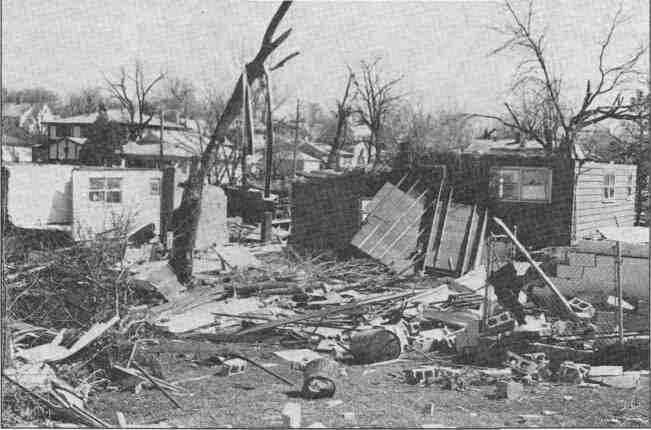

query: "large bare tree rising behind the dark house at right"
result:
(478, 1), (647, 156)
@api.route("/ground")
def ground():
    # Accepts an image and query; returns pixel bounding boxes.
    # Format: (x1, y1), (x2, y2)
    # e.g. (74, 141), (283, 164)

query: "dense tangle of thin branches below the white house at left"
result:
(3, 239), (137, 330)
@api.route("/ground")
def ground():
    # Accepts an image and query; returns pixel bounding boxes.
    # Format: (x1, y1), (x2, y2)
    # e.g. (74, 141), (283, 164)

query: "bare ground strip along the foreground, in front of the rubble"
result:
(88, 340), (650, 428)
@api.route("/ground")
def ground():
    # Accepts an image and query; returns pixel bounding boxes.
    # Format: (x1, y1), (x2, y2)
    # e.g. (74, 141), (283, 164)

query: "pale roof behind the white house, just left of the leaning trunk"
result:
(122, 129), (208, 158)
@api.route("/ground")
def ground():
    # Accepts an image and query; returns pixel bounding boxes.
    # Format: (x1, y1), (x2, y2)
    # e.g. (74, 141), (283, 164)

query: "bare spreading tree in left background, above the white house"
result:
(104, 60), (165, 137)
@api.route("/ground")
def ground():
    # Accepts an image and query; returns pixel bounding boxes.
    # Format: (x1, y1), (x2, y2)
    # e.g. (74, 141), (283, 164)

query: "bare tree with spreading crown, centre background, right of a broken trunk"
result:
(353, 57), (402, 163)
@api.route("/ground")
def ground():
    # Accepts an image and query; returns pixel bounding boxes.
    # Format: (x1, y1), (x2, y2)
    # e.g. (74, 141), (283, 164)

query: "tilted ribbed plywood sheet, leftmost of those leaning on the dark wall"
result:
(351, 183), (426, 272)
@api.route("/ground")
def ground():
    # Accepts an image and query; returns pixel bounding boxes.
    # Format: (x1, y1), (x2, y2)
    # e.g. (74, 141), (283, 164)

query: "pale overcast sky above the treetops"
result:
(2, 0), (649, 113)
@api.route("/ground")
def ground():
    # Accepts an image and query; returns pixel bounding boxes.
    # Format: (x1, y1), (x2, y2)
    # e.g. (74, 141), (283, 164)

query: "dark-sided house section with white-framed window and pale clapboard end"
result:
(431, 139), (637, 248)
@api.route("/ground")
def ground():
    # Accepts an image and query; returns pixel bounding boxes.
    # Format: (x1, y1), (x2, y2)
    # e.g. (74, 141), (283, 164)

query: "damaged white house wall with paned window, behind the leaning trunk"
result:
(3, 163), (228, 242)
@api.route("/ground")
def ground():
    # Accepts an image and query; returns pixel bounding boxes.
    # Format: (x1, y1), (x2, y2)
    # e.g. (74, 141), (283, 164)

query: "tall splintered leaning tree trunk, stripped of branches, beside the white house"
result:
(170, 1), (298, 282)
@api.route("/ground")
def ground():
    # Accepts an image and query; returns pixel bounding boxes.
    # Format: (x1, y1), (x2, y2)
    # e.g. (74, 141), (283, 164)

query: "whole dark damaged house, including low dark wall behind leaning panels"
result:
(292, 140), (636, 256)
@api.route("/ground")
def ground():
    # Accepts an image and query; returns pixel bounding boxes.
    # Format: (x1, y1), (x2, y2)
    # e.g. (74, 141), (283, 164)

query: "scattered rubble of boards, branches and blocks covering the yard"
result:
(3, 191), (649, 428)
